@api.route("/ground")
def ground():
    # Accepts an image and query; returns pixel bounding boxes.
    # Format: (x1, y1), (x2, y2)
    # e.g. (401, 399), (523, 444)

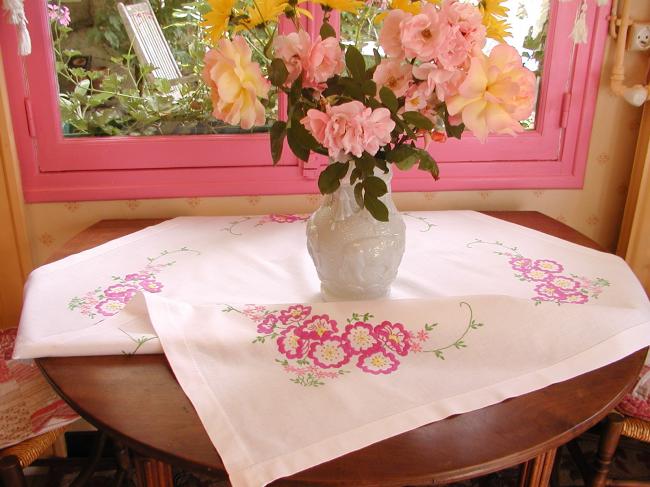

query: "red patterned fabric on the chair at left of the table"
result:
(0, 328), (78, 448)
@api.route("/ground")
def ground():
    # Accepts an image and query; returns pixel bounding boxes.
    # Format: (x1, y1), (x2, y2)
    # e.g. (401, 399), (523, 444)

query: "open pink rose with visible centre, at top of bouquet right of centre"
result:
(400, 4), (440, 62)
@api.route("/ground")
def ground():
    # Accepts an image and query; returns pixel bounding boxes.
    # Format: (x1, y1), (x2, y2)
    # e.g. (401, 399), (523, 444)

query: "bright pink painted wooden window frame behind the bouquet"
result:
(0, 0), (608, 202)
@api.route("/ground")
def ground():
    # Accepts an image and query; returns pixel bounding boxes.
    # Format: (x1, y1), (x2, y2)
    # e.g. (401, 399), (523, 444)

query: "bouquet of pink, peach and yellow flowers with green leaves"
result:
(203, 0), (536, 221)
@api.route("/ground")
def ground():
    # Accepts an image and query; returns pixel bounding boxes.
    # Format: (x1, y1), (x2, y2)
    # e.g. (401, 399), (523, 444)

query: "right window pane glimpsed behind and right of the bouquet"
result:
(341, 0), (549, 130)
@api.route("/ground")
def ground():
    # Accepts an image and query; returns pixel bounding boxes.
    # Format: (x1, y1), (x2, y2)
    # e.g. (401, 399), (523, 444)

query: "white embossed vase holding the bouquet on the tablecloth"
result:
(307, 170), (405, 301)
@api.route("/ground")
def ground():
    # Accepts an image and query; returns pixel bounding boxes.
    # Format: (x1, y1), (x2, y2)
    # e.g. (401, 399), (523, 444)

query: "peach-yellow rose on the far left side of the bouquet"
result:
(203, 36), (270, 129)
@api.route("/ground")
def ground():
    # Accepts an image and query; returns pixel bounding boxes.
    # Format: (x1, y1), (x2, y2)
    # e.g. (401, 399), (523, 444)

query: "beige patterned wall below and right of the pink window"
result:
(26, 1), (650, 264)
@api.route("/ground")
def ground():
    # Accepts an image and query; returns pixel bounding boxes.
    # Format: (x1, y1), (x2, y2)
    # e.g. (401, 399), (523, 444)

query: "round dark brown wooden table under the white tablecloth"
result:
(37, 212), (645, 486)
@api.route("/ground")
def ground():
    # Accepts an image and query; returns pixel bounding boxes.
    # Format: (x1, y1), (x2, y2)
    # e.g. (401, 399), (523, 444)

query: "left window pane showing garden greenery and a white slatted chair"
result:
(47, 0), (277, 137)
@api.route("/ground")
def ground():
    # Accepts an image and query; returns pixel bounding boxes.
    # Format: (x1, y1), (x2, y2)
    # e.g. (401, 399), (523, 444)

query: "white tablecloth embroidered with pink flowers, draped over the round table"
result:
(15, 212), (650, 486)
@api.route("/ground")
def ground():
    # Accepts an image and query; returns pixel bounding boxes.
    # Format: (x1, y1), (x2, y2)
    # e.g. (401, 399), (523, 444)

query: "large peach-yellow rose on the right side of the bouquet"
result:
(447, 44), (535, 141)
